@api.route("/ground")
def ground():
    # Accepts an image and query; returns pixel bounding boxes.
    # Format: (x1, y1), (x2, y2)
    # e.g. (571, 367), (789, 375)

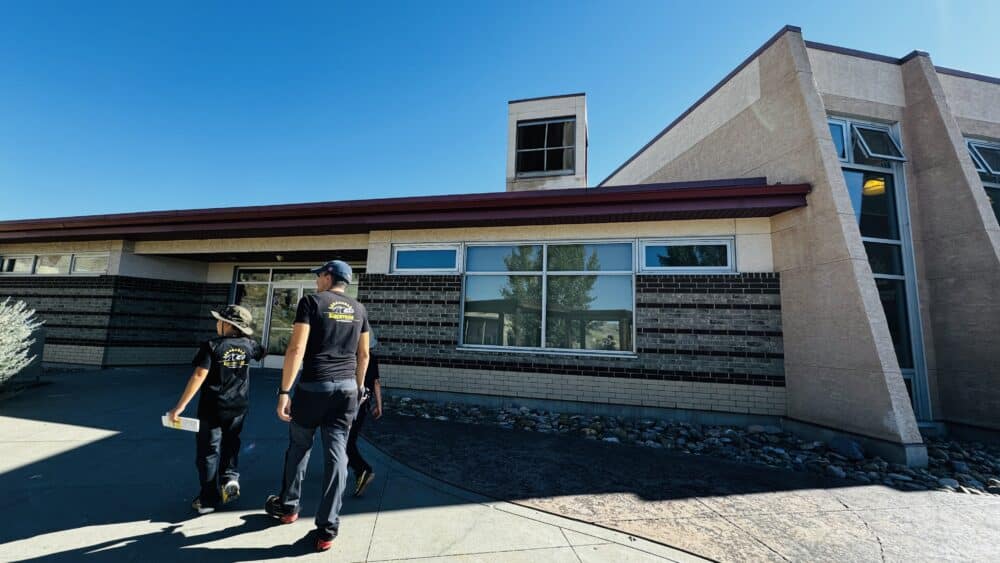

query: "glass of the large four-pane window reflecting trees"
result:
(462, 242), (634, 352)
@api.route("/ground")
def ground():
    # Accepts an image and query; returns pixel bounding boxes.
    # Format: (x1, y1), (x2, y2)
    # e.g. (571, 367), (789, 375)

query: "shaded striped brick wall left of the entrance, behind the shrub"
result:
(0, 276), (229, 366)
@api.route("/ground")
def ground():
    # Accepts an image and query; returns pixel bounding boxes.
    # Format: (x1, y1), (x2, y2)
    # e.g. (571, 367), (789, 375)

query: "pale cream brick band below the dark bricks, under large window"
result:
(379, 364), (785, 416)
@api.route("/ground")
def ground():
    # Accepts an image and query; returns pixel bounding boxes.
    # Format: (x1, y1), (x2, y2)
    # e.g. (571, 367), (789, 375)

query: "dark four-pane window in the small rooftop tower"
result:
(516, 117), (576, 177)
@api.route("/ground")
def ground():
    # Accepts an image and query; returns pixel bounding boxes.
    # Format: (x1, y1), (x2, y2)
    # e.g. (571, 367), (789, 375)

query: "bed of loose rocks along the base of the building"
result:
(385, 393), (1000, 495)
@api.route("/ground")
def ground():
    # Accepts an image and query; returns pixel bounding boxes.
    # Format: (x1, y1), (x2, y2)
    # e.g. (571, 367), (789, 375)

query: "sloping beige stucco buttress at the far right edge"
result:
(901, 57), (1000, 429)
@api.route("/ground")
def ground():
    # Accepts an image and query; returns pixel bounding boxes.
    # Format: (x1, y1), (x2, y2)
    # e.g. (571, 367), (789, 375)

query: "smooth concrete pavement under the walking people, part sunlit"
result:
(0, 368), (698, 563)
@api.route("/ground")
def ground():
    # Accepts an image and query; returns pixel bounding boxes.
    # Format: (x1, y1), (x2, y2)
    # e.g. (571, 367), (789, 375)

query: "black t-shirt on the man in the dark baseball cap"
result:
(295, 291), (369, 382)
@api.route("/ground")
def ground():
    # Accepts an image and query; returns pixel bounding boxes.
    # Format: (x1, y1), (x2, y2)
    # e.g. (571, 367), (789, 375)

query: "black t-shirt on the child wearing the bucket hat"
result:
(191, 336), (264, 418)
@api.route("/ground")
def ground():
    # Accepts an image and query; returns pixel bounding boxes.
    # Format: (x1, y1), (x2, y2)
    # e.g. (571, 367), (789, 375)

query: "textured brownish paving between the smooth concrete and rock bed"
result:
(367, 398), (1000, 562)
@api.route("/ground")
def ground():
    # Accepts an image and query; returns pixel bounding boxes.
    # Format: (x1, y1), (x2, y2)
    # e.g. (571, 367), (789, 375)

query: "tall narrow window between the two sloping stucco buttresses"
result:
(830, 115), (930, 418)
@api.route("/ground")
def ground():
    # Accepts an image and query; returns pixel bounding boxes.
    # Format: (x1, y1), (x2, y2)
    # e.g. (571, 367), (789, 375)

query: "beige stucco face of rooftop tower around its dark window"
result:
(507, 95), (587, 192)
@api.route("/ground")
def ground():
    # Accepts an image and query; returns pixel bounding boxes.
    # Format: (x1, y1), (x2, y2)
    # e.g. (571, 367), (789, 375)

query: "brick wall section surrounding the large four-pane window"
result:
(359, 273), (785, 414)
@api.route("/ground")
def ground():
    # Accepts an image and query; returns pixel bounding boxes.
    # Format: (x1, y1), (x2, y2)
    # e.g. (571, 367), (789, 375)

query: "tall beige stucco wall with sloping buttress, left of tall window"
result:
(592, 32), (926, 463)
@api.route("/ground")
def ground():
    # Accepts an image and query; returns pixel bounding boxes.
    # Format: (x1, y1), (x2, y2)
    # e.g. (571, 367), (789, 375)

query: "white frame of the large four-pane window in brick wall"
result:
(458, 239), (637, 358)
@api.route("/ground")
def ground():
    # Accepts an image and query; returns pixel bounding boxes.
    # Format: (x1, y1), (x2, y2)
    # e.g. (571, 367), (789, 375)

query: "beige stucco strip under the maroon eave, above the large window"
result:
(368, 217), (774, 274)
